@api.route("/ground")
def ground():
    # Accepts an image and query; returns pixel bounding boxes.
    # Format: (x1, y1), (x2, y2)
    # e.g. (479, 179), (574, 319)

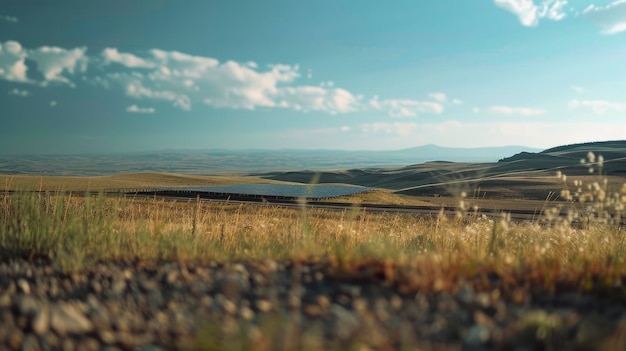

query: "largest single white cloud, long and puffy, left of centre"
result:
(101, 49), (362, 114)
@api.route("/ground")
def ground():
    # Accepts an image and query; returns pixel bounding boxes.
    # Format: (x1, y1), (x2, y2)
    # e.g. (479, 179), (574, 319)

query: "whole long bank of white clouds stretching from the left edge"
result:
(0, 41), (447, 117)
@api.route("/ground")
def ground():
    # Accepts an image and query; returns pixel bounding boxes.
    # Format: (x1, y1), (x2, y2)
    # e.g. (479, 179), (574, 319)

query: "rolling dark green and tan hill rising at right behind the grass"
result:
(258, 141), (626, 200)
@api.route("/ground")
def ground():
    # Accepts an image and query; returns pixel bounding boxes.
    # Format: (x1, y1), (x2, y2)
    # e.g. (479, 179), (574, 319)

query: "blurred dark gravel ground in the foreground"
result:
(0, 260), (626, 351)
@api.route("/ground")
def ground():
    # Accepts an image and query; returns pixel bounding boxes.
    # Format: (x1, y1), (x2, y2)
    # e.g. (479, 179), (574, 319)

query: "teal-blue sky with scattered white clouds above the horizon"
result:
(0, 0), (626, 154)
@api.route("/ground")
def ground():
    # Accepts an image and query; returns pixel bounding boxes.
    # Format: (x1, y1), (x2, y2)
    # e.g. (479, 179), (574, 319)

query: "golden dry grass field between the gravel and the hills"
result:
(0, 164), (626, 288)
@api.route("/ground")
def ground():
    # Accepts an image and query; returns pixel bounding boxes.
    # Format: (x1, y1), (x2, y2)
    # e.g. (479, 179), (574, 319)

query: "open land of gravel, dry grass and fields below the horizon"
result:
(0, 142), (626, 350)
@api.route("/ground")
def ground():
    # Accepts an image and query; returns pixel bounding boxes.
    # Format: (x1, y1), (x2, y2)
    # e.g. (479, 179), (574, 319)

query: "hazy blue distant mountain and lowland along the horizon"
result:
(0, 145), (540, 175)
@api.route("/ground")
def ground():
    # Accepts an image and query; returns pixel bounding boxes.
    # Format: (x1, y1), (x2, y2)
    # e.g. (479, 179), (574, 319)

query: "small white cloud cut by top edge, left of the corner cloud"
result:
(494, 0), (568, 27)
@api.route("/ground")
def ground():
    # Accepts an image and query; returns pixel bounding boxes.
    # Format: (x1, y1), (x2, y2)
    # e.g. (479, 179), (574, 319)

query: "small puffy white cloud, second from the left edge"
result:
(28, 46), (88, 85)
